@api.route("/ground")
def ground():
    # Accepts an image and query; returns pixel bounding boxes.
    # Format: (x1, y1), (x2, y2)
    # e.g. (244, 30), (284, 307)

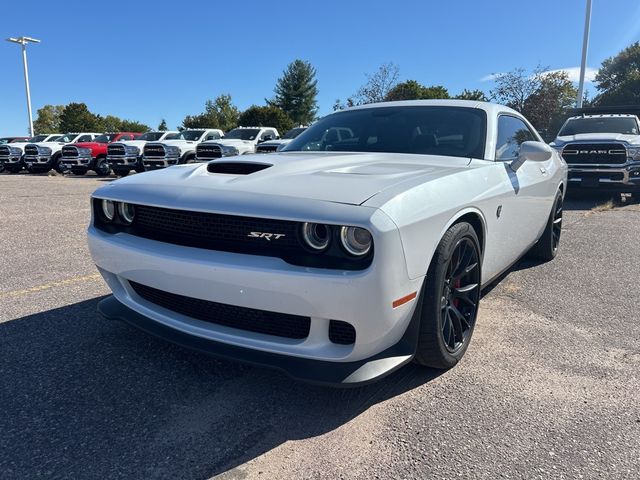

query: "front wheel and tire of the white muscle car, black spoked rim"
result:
(414, 222), (481, 369)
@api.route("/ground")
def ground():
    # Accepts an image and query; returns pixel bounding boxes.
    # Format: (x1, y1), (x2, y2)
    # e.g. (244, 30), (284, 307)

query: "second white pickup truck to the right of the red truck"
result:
(142, 128), (224, 170)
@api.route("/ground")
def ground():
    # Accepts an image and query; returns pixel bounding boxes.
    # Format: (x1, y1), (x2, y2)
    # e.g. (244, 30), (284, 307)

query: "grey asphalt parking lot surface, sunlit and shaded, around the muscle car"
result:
(0, 174), (640, 479)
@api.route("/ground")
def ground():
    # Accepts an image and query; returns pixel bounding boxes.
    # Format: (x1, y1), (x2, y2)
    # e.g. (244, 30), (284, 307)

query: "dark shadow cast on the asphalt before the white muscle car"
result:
(0, 298), (440, 479)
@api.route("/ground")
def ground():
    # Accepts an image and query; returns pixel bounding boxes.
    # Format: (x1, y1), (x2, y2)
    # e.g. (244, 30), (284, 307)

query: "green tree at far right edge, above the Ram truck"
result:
(593, 42), (640, 105)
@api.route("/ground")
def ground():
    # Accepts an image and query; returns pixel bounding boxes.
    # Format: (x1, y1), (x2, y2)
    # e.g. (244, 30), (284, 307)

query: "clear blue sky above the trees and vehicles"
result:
(0, 0), (640, 135)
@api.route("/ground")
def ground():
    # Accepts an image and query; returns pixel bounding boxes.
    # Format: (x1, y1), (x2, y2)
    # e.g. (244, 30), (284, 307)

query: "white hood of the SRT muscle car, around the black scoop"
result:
(101, 152), (470, 205)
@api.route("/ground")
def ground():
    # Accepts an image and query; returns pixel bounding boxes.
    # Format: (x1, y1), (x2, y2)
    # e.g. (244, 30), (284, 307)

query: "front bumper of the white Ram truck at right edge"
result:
(568, 162), (640, 192)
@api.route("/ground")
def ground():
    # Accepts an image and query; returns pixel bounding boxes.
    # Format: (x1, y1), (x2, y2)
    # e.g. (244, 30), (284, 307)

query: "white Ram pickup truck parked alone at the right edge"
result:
(551, 114), (640, 194)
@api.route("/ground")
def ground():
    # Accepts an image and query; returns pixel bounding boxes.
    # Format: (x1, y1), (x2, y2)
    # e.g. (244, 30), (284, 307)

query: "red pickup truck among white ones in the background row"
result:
(60, 132), (141, 177)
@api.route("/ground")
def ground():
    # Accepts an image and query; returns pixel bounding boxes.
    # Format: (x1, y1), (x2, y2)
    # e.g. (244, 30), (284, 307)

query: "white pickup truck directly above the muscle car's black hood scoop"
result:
(196, 127), (280, 162)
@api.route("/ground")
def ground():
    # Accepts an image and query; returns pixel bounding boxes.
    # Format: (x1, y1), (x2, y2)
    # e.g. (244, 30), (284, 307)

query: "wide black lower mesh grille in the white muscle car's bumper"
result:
(129, 281), (311, 340)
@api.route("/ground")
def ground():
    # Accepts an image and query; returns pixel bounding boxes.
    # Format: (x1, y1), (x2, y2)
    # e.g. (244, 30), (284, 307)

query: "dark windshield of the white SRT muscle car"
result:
(282, 106), (487, 158)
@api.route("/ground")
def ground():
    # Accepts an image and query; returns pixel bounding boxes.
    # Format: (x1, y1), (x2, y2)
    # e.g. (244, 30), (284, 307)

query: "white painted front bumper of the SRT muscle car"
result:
(88, 205), (424, 382)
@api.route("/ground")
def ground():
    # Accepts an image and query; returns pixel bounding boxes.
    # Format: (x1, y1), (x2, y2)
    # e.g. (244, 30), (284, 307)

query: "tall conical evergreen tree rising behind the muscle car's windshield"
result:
(267, 60), (318, 125)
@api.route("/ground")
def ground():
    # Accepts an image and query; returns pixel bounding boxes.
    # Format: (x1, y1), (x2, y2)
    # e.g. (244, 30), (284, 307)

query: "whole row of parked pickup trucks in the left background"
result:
(0, 127), (305, 176)
